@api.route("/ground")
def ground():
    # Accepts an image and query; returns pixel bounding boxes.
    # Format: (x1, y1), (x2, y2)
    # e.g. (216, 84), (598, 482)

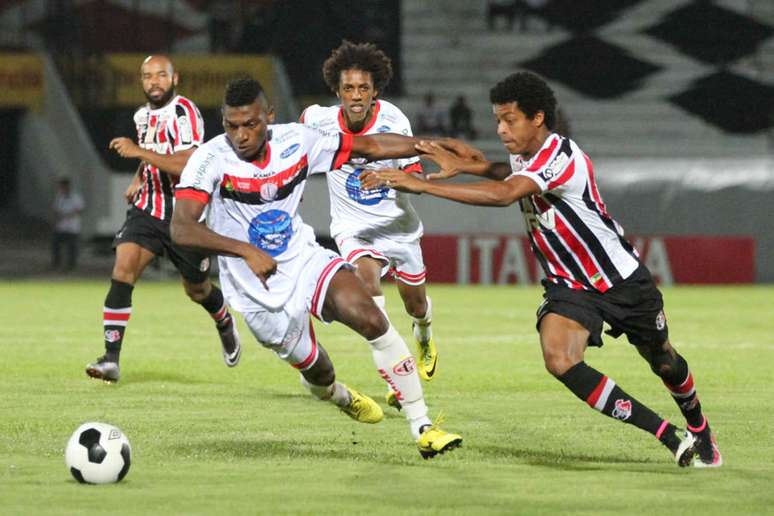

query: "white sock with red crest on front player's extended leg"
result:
(368, 325), (430, 439)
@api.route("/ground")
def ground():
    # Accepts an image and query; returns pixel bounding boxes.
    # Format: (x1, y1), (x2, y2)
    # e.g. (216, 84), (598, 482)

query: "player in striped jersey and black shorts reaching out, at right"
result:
(363, 72), (723, 467)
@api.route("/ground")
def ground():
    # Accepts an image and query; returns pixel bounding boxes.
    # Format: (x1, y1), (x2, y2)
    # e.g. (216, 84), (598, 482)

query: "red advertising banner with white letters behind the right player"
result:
(422, 234), (755, 285)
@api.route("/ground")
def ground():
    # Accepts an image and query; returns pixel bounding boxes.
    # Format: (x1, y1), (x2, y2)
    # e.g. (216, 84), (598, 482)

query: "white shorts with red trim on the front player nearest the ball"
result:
(242, 247), (351, 371)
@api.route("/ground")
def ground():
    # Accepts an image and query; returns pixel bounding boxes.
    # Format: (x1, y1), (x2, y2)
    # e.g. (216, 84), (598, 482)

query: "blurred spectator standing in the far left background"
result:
(51, 177), (84, 271)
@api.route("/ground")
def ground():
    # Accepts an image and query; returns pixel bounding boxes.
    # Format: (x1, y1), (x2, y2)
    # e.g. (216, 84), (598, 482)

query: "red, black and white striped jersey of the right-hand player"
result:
(510, 134), (640, 292)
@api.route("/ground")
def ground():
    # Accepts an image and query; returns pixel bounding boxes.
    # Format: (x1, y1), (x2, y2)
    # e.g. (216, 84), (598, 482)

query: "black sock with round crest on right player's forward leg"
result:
(559, 362), (669, 442)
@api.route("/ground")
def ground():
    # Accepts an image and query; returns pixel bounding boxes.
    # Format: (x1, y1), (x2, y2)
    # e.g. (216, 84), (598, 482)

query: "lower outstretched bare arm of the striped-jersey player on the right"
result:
(360, 168), (540, 206)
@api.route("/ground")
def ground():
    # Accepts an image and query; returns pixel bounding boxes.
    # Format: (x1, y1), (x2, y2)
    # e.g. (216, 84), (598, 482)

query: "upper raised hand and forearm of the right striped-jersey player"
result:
(416, 138), (511, 180)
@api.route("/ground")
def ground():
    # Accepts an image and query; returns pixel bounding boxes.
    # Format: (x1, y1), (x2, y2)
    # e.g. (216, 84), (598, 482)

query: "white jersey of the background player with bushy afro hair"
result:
(301, 100), (423, 242)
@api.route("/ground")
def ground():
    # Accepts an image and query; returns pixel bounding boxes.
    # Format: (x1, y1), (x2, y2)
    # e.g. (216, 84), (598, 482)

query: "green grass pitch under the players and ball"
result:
(0, 279), (774, 515)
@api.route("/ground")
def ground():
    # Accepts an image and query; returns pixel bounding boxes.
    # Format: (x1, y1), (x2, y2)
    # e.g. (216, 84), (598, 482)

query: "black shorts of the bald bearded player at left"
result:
(113, 206), (210, 283)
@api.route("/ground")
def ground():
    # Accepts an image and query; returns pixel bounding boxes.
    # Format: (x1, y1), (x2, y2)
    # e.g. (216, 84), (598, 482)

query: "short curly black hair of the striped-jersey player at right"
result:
(489, 72), (556, 130)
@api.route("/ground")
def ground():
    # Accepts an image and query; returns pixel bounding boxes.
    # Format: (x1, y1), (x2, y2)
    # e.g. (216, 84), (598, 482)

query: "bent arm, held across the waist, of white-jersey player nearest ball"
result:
(170, 197), (277, 290)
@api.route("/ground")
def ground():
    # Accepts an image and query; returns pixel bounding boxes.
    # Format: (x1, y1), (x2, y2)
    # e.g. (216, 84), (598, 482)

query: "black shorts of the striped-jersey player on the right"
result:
(537, 265), (669, 346)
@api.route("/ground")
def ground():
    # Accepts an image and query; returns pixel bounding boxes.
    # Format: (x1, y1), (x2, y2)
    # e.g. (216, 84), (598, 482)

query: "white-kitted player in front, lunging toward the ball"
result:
(172, 79), (462, 458)
